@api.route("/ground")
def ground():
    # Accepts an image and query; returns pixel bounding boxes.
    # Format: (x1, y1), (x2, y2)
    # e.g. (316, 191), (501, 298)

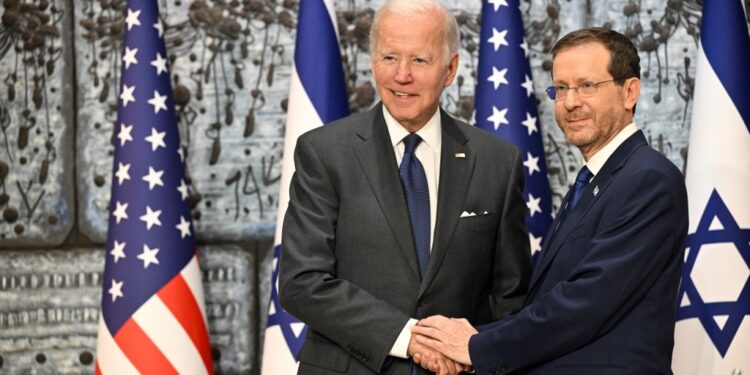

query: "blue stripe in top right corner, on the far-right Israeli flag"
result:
(701, 0), (750, 131)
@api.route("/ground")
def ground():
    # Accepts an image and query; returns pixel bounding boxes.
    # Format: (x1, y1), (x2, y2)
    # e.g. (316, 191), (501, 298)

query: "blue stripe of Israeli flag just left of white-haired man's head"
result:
(294, 0), (349, 123)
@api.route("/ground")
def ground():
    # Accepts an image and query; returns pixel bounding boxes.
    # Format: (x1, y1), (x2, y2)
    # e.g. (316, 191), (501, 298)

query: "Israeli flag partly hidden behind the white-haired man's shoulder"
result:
(262, 0), (349, 375)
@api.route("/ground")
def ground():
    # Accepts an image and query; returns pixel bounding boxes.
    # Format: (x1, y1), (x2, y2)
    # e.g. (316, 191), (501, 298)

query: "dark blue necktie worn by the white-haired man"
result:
(399, 133), (430, 277)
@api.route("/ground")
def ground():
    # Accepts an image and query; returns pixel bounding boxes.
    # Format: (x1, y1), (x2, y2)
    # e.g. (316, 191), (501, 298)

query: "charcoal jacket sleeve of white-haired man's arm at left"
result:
(279, 136), (409, 372)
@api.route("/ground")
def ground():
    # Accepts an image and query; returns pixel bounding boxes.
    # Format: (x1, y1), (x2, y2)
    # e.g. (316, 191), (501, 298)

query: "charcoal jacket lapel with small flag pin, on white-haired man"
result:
(419, 110), (476, 296)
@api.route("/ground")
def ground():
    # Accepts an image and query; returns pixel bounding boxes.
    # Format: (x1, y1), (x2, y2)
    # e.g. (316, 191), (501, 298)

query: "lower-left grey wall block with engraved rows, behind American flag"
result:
(0, 245), (257, 374)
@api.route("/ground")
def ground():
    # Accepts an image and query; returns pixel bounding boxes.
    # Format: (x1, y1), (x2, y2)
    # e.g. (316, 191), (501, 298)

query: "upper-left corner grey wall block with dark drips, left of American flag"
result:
(0, 0), (75, 246)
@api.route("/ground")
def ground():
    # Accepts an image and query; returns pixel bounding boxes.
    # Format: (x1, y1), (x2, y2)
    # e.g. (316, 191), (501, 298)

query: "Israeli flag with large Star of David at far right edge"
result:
(672, 0), (750, 375)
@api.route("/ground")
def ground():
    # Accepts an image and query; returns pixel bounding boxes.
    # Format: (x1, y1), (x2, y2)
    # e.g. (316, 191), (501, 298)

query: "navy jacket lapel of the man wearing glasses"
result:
(527, 130), (647, 298)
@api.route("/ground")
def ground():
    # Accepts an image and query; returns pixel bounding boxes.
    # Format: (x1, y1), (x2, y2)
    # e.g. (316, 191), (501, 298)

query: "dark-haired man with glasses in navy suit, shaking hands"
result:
(414, 28), (688, 375)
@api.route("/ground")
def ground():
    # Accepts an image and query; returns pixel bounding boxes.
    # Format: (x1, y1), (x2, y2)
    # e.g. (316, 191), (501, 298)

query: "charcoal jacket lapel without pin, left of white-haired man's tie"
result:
(352, 104), (419, 279)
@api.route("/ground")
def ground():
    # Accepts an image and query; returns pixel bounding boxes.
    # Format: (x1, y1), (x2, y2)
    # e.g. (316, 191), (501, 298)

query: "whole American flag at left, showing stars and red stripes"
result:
(96, 0), (213, 374)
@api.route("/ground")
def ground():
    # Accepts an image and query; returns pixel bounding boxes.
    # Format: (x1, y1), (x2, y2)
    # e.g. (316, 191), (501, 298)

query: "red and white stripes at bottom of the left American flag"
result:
(96, 255), (213, 375)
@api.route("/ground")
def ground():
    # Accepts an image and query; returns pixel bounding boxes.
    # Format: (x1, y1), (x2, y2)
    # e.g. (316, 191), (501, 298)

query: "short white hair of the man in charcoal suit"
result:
(370, 0), (460, 60)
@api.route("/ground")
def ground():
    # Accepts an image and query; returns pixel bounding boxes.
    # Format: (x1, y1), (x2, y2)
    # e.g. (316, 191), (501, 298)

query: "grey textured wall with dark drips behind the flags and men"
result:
(0, 0), (750, 374)
